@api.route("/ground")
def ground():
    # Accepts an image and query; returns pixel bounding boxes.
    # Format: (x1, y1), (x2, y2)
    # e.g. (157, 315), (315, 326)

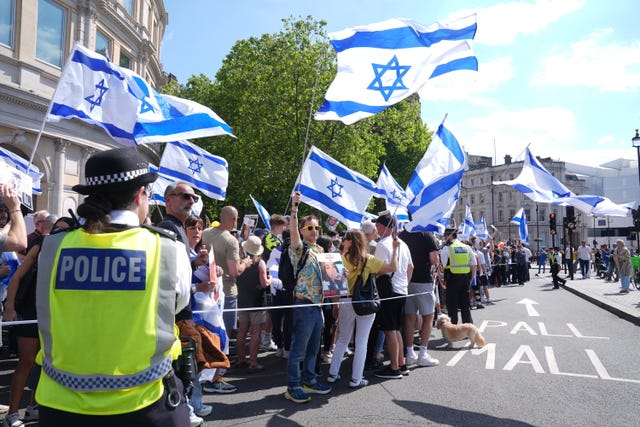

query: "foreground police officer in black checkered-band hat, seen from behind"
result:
(36, 148), (191, 427)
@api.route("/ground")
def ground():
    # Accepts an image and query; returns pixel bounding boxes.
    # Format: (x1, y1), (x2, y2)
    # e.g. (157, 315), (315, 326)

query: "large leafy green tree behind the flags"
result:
(171, 17), (431, 224)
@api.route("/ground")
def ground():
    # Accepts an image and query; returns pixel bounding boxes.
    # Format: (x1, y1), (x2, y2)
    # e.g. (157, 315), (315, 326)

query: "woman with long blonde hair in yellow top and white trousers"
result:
(327, 229), (400, 388)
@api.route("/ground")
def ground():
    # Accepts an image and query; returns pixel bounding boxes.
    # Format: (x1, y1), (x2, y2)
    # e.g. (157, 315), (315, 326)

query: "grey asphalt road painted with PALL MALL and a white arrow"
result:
(0, 276), (640, 426)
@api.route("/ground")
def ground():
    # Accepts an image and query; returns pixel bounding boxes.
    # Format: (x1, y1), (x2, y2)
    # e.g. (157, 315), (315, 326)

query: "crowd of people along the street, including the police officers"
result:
(0, 148), (630, 427)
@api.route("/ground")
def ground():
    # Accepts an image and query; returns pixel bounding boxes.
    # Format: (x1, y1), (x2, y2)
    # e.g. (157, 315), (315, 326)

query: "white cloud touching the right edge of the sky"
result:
(531, 29), (640, 92)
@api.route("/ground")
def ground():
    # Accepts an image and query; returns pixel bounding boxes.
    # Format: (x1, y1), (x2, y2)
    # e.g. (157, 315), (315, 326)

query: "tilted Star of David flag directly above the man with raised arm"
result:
(294, 146), (376, 228)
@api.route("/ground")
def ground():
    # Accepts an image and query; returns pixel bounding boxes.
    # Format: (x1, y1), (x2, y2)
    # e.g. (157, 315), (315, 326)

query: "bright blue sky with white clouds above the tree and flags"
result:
(161, 0), (640, 166)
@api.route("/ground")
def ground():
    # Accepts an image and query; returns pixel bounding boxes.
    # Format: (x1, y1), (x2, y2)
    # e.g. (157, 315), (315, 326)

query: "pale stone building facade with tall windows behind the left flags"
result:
(0, 0), (168, 215)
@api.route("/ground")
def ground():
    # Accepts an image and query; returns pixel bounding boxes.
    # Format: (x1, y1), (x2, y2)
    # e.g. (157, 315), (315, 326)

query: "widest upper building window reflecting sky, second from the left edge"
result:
(36, 0), (67, 67)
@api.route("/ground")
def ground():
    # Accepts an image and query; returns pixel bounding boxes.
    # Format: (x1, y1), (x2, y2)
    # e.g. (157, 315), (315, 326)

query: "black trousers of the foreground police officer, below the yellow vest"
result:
(38, 384), (189, 427)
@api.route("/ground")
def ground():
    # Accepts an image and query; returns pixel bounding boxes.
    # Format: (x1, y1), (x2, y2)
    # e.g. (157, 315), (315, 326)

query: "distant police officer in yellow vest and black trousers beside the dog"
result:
(440, 228), (477, 324)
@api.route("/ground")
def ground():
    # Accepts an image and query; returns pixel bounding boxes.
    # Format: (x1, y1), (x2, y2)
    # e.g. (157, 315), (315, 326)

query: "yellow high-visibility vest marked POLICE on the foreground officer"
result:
(36, 227), (180, 415)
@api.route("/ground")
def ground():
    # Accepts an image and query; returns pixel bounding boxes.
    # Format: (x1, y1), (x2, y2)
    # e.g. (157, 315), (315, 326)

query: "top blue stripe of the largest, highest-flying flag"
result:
(331, 23), (478, 53)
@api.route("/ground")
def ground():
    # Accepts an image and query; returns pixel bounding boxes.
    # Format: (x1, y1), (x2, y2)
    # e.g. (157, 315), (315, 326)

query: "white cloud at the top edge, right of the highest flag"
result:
(464, 0), (586, 46)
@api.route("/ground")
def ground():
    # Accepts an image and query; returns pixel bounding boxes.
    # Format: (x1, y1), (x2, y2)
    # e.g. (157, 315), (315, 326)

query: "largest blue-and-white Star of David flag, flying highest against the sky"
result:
(315, 14), (478, 124)
